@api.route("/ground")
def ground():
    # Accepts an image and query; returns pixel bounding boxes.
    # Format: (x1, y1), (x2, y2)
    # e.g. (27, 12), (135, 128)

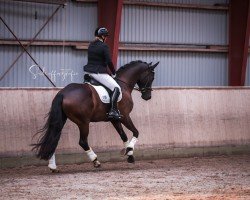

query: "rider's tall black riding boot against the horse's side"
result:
(108, 87), (121, 120)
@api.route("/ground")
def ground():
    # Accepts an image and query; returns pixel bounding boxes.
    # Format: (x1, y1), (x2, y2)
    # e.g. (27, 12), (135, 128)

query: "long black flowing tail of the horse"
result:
(33, 93), (67, 160)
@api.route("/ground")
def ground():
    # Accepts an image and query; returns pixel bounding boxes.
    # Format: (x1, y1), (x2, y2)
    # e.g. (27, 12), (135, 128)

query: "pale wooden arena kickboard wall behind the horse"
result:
(0, 88), (250, 167)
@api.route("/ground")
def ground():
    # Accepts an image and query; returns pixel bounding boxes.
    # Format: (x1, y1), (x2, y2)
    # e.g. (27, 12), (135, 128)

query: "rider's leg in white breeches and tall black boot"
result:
(91, 74), (121, 119)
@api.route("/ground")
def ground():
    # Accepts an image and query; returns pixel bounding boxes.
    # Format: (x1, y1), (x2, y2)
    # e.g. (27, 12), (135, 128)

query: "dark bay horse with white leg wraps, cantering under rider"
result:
(33, 61), (159, 172)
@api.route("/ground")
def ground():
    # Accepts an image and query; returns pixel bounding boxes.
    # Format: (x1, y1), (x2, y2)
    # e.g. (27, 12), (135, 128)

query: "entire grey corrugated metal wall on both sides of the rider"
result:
(0, 0), (228, 87)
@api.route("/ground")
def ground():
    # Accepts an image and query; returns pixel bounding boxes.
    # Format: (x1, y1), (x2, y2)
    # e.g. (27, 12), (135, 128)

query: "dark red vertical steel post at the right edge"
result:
(228, 0), (250, 86)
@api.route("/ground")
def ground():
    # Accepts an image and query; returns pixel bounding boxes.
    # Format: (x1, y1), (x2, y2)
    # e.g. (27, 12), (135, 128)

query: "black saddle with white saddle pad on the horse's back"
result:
(84, 74), (122, 104)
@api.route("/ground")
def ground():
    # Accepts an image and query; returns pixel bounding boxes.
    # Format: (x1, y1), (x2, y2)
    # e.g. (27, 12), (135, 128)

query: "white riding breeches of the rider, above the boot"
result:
(88, 73), (121, 93)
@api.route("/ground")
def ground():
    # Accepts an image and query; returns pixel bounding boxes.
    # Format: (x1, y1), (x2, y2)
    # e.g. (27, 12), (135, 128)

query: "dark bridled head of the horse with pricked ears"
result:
(137, 62), (159, 101)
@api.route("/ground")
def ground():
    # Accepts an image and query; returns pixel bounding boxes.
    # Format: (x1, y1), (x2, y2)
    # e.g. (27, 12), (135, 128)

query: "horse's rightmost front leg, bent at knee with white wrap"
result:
(122, 116), (139, 163)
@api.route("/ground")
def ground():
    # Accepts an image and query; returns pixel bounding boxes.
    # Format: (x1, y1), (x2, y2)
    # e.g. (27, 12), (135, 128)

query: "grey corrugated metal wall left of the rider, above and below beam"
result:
(0, 2), (97, 87)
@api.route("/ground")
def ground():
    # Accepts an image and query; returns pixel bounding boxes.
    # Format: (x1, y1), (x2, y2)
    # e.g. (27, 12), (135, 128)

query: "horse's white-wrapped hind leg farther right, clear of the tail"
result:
(78, 123), (101, 167)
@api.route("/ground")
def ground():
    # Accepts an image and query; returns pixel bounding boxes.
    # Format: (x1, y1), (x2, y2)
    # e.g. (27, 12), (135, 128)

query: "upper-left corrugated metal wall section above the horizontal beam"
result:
(0, 1), (97, 41)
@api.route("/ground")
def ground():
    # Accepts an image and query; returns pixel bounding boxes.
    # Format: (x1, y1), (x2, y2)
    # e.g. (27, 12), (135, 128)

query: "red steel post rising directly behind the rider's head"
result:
(98, 0), (123, 67)
